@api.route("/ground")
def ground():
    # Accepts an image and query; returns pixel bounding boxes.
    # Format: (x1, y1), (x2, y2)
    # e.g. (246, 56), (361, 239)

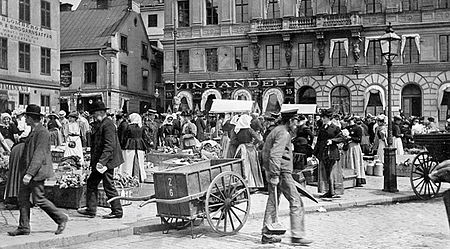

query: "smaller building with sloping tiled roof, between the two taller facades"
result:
(61, 0), (160, 113)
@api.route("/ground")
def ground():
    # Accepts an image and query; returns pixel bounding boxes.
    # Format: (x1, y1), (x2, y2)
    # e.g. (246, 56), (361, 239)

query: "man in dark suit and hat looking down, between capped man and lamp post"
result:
(314, 109), (345, 198)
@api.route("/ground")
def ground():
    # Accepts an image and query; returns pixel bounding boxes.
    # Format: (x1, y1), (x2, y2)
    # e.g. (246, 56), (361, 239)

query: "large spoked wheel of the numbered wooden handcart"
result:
(205, 171), (250, 235)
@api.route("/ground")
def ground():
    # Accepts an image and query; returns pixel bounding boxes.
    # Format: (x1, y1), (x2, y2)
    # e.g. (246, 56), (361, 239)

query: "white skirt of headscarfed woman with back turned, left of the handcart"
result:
(119, 150), (147, 182)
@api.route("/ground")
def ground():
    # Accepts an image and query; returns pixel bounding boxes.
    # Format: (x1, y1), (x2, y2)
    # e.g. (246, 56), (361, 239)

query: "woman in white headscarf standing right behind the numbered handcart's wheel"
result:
(234, 114), (264, 188)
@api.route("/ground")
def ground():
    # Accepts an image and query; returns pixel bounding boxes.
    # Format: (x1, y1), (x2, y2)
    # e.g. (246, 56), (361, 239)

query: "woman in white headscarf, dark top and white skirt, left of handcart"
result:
(119, 113), (147, 182)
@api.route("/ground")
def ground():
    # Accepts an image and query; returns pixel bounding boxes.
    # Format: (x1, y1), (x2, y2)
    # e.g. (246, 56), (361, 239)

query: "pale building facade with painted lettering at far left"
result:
(0, 0), (60, 113)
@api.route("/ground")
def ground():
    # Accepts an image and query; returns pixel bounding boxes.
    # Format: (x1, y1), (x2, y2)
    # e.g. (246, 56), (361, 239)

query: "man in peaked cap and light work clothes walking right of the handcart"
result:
(261, 110), (312, 245)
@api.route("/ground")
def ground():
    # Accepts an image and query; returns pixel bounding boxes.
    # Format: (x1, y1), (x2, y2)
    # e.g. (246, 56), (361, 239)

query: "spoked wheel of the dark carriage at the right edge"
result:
(410, 152), (441, 200)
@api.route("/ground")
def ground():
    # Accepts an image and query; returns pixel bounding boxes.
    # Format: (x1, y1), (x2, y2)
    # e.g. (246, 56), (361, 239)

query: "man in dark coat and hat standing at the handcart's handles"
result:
(78, 102), (124, 219)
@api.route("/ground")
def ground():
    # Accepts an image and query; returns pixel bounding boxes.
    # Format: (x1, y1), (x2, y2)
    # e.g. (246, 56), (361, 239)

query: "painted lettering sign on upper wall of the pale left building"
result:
(0, 16), (58, 49)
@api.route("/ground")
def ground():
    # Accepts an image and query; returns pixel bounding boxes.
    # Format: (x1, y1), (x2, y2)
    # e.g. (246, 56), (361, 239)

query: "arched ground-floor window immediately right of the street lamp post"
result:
(402, 84), (422, 117)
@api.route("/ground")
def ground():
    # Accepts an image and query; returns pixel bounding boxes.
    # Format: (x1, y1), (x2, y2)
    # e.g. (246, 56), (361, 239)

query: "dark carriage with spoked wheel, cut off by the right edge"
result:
(410, 133), (450, 200)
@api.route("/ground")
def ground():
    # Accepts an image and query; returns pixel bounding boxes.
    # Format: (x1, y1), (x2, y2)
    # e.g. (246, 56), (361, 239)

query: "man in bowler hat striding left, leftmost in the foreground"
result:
(8, 104), (68, 236)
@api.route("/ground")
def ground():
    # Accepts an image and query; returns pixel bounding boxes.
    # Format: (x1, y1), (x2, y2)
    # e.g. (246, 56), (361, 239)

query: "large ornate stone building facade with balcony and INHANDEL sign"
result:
(163, 0), (450, 120)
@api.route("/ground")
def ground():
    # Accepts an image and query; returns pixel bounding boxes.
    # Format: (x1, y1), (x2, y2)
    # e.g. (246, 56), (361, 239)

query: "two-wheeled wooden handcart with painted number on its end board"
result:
(109, 159), (250, 237)
